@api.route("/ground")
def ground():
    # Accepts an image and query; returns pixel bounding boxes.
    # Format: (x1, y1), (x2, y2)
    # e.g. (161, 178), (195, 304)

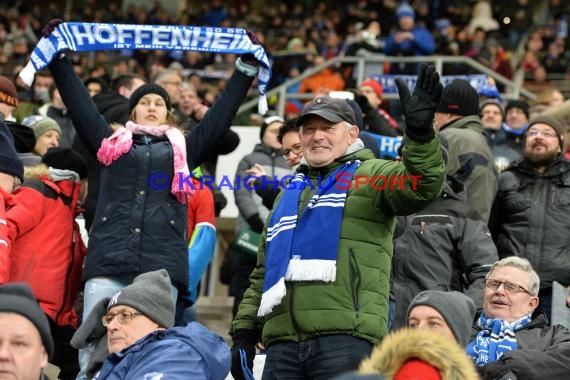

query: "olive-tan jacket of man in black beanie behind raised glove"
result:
(440, 116), (497, 222)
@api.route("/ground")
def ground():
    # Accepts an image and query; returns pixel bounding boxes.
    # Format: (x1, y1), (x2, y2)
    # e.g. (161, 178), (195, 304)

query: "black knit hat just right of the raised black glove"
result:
(437, 79), (479, 116)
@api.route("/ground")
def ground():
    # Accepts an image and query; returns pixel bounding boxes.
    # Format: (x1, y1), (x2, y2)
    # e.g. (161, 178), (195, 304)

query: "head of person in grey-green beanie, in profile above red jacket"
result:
(22, 115), (61, 166)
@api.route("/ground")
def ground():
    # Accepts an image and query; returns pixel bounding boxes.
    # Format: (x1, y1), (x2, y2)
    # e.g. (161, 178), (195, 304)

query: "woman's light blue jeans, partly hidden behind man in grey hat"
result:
(76, 275), (178, 380)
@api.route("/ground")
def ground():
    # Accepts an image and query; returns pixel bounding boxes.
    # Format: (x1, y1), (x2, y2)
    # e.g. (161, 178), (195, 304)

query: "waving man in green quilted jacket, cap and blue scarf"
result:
(232, 65), (445, 379)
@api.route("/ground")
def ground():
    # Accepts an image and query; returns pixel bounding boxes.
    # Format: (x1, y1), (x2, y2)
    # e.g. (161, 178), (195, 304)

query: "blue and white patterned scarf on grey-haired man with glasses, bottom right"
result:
(467, 313), (531, 366)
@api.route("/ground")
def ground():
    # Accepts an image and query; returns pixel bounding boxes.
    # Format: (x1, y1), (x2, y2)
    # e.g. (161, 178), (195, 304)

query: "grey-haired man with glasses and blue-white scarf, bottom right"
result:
(467, 256), (570, 380)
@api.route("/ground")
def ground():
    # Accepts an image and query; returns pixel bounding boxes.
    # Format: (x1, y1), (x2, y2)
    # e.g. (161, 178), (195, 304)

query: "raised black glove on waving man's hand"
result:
(396, 63), (443, 142)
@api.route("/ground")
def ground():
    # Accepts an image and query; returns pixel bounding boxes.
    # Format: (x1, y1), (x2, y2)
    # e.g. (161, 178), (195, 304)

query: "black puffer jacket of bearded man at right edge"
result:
(490, 155), (570, 289)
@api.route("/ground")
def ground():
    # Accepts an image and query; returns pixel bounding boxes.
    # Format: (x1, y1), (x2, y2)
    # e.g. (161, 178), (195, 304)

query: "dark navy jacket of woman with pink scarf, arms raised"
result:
(49, 58), (253, 290)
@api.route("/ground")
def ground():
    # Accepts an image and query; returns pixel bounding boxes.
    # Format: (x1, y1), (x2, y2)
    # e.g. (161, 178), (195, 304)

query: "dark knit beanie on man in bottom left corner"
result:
(0, 282), (54, 358)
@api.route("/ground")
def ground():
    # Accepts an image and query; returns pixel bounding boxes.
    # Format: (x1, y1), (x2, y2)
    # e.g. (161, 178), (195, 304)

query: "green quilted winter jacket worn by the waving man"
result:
(233, 138), (445, 346)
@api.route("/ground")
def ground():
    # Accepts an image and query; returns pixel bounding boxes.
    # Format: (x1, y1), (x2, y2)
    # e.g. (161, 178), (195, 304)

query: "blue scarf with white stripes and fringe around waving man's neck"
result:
(257, 161), (360, 317)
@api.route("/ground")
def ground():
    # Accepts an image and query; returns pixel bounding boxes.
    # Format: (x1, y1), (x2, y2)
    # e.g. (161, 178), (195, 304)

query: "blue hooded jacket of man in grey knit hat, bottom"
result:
(93, 322), (231, 380)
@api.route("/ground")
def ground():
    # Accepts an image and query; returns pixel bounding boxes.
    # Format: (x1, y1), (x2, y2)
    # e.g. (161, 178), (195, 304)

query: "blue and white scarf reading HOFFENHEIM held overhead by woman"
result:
(20, 22), (271, 115)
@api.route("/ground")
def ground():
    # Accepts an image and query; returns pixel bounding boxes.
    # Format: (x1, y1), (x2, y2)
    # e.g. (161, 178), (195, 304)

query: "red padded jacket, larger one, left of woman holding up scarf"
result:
(6, 169), (85, 327)
